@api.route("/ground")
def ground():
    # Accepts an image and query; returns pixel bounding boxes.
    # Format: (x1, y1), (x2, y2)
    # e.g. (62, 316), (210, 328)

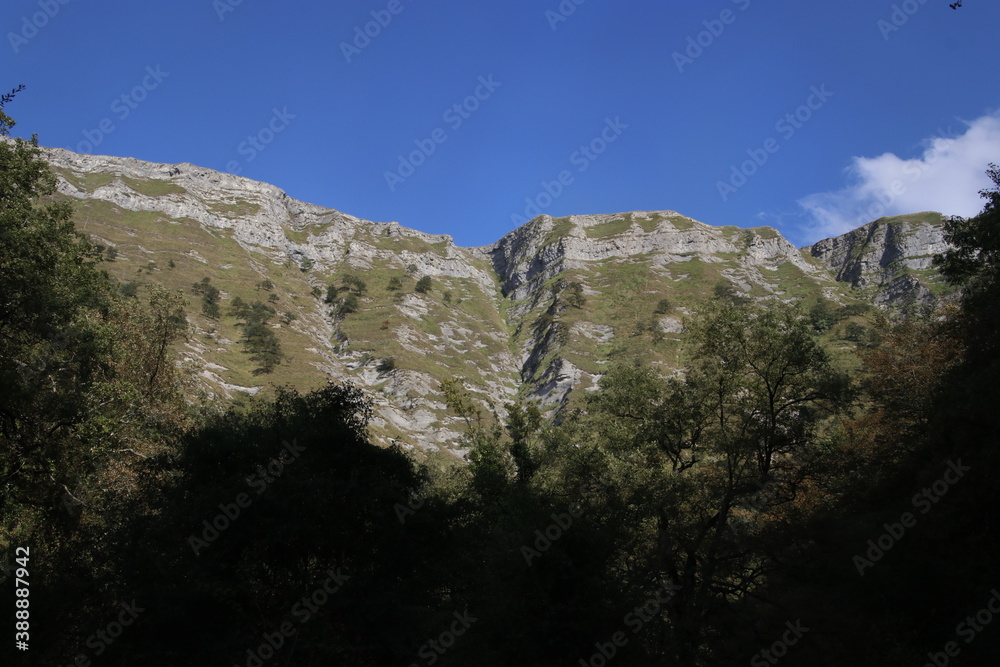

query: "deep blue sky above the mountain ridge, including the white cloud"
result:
(0, 0), (1000, 246)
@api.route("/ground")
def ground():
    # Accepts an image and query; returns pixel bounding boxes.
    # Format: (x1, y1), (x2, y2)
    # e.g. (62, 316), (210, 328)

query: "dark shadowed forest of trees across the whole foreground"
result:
(0, 90), (1000, 667)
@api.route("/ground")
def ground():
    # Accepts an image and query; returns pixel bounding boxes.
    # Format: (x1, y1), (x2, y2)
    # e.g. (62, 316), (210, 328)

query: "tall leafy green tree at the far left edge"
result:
(0, 88), (117, 470)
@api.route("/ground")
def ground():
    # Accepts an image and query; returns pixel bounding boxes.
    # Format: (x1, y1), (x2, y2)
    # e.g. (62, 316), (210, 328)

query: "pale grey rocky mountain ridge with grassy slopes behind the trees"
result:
(39, 149), (945, 455)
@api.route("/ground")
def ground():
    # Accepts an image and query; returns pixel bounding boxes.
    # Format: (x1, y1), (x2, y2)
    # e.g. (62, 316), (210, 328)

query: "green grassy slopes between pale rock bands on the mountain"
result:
(62, 172), (888, 446)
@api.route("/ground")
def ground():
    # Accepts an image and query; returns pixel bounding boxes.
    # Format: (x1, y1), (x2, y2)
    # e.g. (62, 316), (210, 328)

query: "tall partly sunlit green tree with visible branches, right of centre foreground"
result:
(576, 302), (844, 665)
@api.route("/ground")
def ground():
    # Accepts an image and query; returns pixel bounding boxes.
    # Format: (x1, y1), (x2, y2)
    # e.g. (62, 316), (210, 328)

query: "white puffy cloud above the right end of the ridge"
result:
(798, 112), (1000, 239)
